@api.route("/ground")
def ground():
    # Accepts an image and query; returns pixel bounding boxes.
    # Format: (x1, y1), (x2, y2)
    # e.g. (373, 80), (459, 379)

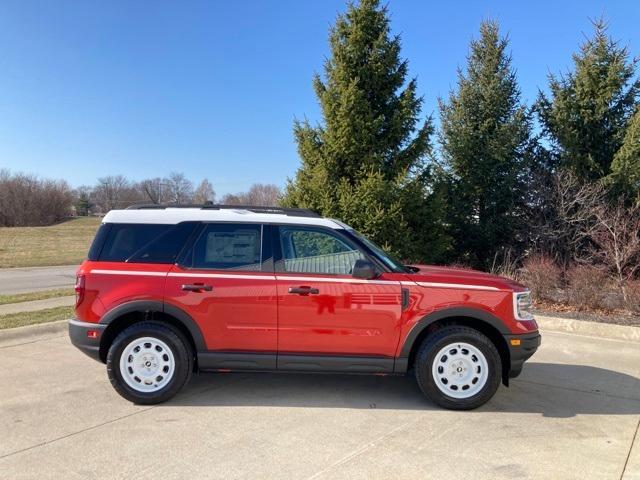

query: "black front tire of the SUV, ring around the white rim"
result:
(414, 326), (502, 410)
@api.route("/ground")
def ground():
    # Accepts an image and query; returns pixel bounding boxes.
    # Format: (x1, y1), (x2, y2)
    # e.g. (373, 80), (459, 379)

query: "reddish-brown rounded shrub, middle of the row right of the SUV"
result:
(566, 265), (612, 310)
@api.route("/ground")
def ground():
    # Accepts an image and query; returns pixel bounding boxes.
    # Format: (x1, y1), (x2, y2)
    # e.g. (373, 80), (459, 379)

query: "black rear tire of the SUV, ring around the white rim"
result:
(107, 321), (193, 405)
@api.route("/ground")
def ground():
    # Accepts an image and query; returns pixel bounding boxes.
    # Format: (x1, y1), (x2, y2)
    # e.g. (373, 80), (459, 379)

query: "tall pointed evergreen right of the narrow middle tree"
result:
(537, 20), (640, 180)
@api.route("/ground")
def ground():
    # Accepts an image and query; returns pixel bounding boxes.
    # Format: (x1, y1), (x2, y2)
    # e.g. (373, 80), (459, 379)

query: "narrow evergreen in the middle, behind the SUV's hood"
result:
(440, 21), (531, 267)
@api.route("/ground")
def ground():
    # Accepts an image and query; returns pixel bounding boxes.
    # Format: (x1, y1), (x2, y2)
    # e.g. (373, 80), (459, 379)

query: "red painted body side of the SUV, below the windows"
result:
(76, 261), (537, 357)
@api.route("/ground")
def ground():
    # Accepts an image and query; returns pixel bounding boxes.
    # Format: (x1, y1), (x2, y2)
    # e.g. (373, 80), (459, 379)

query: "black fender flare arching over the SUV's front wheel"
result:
(395, 307), (511, 372)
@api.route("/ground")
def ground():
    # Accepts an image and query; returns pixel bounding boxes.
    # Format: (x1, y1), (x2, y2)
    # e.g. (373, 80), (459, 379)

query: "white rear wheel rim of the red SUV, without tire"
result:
(120, 337), (176, 392)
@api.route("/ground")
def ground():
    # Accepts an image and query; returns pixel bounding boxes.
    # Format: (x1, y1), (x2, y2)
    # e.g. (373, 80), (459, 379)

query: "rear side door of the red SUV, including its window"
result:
(165, 223), (277, 369)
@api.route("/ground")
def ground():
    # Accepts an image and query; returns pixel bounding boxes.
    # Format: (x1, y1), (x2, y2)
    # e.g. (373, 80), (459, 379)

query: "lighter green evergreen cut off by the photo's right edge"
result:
(611, 106), (640, 203)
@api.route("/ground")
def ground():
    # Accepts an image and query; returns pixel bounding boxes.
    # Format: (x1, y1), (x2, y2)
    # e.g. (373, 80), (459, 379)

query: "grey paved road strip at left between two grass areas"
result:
(0, 265), (78, 295)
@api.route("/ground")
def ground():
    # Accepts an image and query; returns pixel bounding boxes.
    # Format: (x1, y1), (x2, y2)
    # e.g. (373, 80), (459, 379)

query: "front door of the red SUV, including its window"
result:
(273, 225), (402, 364)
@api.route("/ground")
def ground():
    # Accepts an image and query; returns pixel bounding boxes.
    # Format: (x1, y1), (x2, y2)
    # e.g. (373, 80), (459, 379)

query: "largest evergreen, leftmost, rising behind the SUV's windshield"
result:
(282, 0), (447, 260)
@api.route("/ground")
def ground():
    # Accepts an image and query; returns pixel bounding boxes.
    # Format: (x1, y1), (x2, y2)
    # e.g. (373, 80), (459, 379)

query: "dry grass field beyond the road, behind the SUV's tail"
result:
(0, 217), (102, 268)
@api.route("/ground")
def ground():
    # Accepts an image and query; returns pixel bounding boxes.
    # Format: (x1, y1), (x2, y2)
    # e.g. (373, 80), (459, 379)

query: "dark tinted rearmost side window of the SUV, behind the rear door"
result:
(92, 222), (195, 263)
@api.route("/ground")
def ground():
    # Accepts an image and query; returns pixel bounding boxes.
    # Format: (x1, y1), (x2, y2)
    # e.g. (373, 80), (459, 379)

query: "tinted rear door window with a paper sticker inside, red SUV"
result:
(192, 223), (262, 271)
